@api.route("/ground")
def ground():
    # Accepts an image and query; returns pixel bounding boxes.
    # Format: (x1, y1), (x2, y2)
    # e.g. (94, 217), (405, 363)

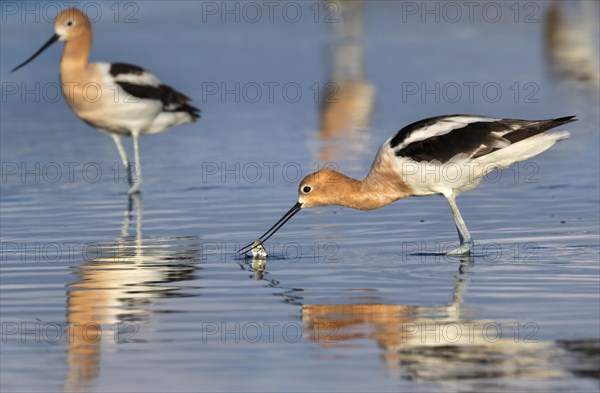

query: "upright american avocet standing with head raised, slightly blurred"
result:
(11, 8), (200, 194)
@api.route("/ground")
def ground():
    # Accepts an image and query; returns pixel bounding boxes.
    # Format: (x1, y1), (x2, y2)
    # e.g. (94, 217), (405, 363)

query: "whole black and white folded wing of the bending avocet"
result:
(388, 115), (575, 163)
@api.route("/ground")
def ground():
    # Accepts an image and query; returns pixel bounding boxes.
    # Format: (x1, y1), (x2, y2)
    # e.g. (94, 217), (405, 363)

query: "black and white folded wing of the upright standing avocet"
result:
(109, 63), (200, 119)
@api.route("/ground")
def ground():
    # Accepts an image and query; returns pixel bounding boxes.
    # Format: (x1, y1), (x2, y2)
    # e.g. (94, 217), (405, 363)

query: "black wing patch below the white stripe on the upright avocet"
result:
(116, 82), (200, 119)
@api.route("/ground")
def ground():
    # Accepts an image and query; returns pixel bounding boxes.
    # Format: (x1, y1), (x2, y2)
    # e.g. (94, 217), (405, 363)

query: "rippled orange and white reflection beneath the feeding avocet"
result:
(302, 257), (600, 391)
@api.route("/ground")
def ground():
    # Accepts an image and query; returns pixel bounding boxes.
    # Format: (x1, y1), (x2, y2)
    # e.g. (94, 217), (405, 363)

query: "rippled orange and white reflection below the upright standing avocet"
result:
(65, 194), (200, 392)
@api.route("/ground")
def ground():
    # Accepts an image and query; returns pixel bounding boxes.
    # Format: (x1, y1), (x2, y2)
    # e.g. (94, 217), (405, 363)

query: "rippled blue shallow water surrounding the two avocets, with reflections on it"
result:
(0, 1), (600, 392)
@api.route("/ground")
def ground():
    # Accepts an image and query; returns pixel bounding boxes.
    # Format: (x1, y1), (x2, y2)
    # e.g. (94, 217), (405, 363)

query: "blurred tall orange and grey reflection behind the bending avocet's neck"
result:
(317, 0), (375, 164)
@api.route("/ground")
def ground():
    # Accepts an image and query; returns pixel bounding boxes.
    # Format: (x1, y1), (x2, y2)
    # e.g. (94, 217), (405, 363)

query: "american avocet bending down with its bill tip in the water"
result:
(238, 115), (576, 255)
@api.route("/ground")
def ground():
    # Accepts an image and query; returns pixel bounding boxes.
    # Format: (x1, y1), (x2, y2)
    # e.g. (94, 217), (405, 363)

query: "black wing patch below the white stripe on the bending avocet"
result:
(395, 116), (575, 163)
